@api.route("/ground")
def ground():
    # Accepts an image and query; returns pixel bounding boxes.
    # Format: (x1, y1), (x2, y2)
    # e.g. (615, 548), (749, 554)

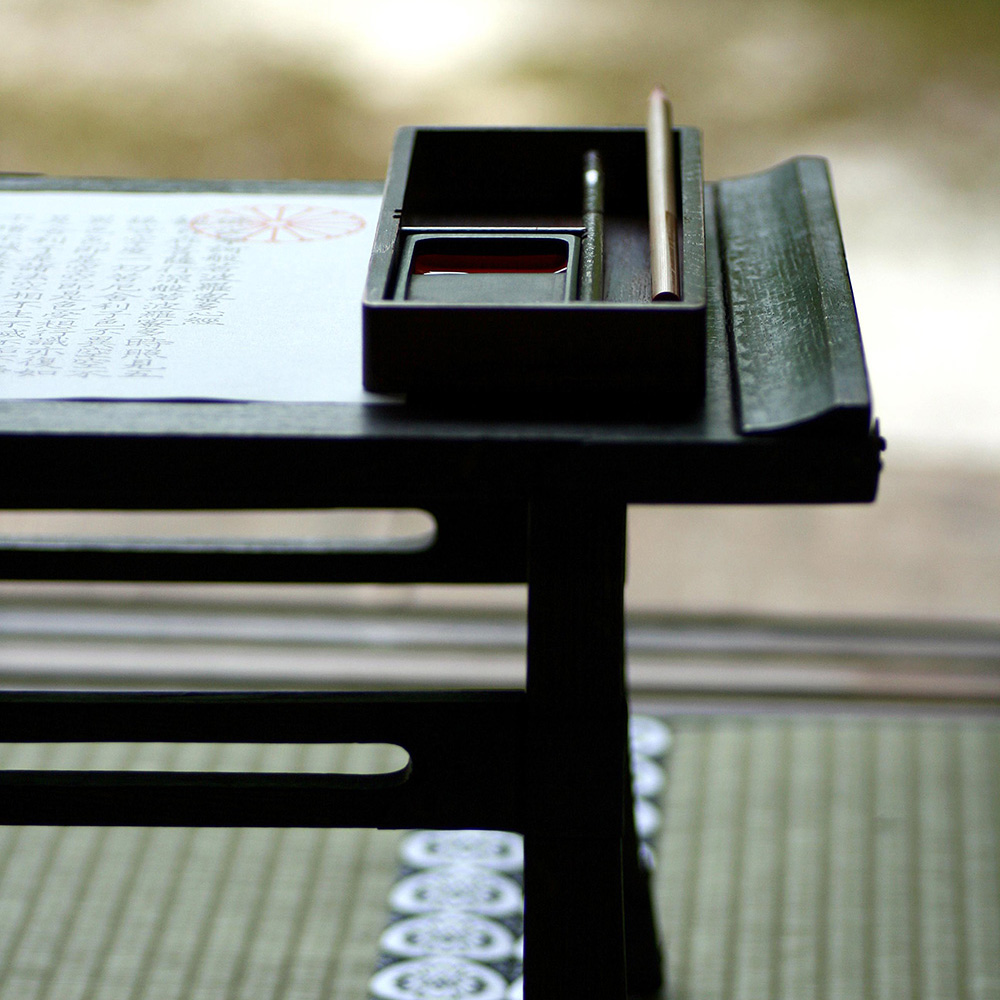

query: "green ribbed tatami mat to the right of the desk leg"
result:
(658, 717), (1000, 1000)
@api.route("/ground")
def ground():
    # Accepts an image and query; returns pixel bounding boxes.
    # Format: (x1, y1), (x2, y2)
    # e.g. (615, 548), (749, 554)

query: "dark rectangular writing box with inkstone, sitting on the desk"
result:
(362, 127), (706, 413)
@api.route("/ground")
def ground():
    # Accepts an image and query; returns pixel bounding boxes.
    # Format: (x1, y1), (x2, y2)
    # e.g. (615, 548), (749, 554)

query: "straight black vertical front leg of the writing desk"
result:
(524, 497), (627, 1000)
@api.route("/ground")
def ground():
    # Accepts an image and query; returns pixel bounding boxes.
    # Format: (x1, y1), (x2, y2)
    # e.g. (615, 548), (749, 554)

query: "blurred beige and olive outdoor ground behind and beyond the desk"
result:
(0, 0), (1000, 620)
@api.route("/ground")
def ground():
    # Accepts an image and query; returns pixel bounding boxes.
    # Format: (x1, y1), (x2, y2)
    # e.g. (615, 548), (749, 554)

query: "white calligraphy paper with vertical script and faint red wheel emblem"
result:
(0, 191), (383, 402)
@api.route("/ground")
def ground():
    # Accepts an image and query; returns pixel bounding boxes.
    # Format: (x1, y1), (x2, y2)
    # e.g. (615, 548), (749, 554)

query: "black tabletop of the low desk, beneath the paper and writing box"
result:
(0, 173), (881, 509)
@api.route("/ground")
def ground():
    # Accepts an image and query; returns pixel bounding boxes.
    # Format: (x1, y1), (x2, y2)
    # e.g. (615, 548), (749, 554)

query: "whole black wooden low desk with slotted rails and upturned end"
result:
(0, 168), (881, 1000)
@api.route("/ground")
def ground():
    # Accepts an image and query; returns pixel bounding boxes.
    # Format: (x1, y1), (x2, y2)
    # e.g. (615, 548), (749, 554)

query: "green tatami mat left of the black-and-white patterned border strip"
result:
(0, 745), (406, 1000)
